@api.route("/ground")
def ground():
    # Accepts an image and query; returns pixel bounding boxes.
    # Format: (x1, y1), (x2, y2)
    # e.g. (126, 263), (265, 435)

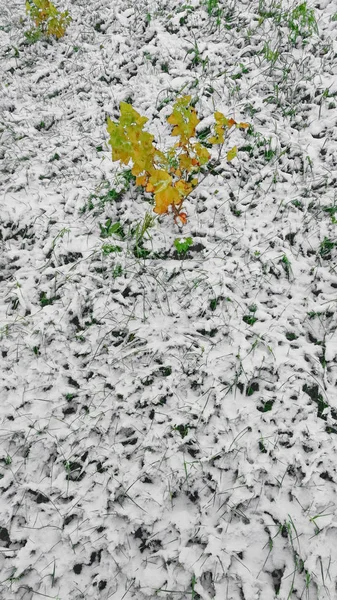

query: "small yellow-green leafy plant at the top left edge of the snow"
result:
(26, 0), (71, 39)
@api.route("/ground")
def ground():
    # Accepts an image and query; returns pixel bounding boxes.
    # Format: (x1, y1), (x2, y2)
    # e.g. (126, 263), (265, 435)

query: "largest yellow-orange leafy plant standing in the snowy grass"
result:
(107, 96), (249, 224)
